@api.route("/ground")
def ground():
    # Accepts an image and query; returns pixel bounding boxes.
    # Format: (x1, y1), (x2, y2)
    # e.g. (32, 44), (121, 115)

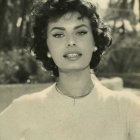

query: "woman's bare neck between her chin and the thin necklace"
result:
(57, 68), (93, 98)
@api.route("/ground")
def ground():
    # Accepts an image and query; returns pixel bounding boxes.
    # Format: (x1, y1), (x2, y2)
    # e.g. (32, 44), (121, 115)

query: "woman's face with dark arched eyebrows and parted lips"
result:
(47, 12), (95, 72)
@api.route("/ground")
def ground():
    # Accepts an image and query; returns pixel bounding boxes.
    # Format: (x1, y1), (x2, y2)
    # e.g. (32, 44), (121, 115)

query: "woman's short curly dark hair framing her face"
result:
(31, 0), (112, 76)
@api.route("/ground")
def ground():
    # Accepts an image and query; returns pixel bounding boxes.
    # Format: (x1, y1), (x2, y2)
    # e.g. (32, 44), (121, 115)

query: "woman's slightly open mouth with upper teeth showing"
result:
(64, 53), (82, 60)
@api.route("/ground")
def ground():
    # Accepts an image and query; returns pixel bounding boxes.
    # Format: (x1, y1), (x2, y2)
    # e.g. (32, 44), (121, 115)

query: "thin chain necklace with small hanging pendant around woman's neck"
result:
(55, 83), (94, 105)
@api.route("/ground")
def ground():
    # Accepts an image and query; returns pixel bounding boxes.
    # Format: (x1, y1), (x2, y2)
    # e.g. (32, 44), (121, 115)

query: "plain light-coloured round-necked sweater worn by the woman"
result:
(0, 79), (140, 140)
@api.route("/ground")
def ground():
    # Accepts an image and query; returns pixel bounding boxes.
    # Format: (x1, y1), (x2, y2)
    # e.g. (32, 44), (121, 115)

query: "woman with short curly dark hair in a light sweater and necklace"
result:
(0, 0), (140, 140)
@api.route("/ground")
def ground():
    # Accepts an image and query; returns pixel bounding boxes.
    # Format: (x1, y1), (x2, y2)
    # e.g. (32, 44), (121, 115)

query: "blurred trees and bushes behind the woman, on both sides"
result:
(0, 0), (140, 88)
